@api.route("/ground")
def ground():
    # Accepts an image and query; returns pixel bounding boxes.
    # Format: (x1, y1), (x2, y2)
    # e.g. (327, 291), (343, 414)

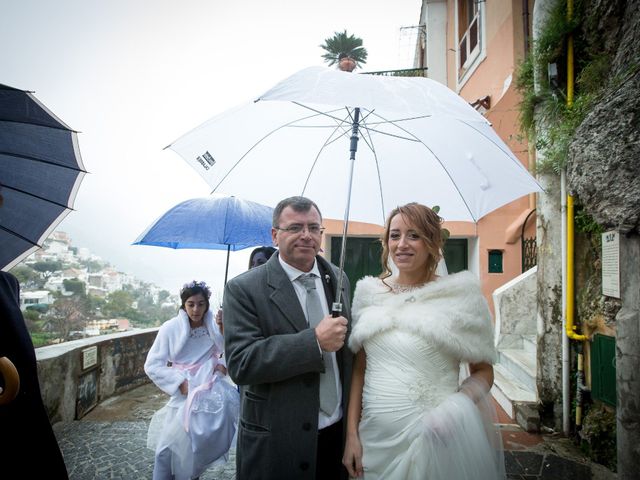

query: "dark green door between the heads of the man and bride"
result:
(331, 237), (382, 296)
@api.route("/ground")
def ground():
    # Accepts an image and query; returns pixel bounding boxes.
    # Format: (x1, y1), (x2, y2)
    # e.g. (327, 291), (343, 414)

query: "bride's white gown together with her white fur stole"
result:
(349, 272), (505, 480)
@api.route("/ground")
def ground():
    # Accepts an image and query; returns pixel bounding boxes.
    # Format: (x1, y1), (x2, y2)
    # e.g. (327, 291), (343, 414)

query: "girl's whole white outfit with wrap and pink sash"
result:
(144, 310), (239, 480)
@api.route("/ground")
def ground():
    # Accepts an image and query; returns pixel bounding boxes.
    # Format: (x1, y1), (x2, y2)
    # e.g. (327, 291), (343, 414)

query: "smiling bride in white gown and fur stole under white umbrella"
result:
(343, 203), (505, 480)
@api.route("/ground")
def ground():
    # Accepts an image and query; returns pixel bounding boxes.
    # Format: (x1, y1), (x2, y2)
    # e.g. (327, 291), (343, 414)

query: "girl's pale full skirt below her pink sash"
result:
(147, 377), (239, 480)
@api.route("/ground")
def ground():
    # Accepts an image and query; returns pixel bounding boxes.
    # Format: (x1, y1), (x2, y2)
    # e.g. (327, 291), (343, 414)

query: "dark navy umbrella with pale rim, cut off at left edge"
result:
(0, 84), (86, 270)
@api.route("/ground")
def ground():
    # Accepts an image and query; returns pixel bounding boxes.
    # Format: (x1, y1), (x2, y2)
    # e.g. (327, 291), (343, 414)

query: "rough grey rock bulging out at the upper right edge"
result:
(567, 0), (640, 233)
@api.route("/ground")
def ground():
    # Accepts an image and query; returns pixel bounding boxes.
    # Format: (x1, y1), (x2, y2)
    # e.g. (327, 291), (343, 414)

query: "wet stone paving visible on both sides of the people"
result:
(54, 384), (616, 480)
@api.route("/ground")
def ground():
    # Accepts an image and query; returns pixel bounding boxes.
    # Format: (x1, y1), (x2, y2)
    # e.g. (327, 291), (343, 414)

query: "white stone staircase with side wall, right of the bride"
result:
(491, 267), (539, 431)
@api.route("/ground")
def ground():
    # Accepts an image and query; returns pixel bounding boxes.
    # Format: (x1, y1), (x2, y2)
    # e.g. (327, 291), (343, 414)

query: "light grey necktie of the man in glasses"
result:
(297, 273), (338, 416)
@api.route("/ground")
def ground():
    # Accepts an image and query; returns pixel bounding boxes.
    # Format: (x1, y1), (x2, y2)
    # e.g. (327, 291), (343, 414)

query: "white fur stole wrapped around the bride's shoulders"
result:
(349, 271), (497, 364)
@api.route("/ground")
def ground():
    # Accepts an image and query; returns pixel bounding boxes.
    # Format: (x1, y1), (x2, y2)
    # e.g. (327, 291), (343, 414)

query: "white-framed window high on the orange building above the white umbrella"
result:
(456, 0), (484, 81)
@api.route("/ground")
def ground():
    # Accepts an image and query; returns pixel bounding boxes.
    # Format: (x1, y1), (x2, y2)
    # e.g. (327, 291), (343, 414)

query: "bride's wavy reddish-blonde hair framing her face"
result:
(380, 202), (444, 280)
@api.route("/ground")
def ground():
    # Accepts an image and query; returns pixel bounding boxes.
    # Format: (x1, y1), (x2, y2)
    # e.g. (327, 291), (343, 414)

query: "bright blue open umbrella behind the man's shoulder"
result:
(133, 196), (273, 284)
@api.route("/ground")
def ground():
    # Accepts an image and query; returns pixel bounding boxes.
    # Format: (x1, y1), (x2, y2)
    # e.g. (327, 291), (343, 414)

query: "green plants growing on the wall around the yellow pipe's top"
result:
(516, 0), (610, 173)
